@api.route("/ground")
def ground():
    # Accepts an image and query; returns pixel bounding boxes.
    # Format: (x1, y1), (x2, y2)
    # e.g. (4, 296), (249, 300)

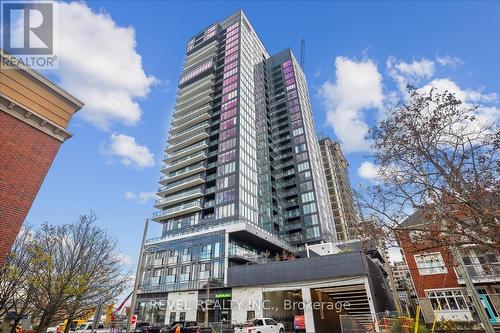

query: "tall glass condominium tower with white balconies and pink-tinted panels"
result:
(141, 11), (336, 293)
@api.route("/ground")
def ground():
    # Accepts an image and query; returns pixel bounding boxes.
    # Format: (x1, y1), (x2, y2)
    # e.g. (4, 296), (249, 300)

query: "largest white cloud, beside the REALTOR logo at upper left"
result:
(58, 2), (156, 129)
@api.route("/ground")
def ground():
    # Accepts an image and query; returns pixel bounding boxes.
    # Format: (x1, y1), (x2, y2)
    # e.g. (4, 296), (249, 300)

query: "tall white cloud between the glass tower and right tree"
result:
(320, 57), (384, 152)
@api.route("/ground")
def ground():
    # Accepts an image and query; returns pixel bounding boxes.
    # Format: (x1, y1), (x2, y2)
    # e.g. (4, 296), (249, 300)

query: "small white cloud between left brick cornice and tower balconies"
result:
(103, 134), (155, 169)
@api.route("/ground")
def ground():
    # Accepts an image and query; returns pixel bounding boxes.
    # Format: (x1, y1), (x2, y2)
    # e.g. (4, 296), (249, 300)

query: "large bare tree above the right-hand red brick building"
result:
(357, 87), (500, 250)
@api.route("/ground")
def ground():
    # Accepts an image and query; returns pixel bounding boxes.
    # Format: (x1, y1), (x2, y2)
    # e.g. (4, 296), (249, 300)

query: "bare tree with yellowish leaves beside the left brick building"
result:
(29, 213), (129, 333)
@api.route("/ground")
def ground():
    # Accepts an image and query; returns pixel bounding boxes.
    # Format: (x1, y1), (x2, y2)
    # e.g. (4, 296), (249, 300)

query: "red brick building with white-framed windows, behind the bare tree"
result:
(398, 210), (500, 325)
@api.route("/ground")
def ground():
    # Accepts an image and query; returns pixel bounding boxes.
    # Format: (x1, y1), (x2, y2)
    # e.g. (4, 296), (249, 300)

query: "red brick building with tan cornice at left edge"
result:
(0, 50), (83, 265)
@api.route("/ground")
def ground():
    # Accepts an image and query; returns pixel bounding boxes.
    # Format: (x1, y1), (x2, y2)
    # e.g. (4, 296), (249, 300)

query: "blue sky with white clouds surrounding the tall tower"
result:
(27, 1), (500, 272)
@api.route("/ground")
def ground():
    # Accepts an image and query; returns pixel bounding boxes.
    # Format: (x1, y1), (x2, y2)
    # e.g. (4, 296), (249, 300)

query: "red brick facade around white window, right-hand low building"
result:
(398, 232), (459, 297)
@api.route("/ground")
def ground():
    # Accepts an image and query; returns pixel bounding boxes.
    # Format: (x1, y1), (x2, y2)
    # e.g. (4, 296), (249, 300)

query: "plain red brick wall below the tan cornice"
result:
(0, 111), (61, 265)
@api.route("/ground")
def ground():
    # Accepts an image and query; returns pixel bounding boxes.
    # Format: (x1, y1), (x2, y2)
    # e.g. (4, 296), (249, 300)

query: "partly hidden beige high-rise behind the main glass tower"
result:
(319, 138), (359, 241)
